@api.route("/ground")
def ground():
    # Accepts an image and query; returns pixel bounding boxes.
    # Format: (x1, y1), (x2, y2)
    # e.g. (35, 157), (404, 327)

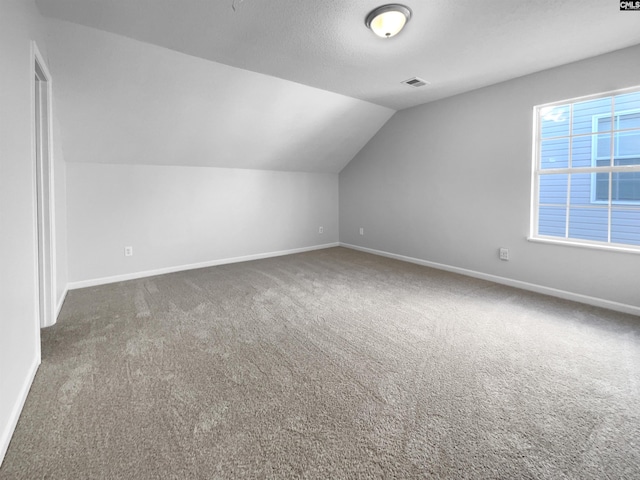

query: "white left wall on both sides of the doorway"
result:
(0, 0), (67, 461)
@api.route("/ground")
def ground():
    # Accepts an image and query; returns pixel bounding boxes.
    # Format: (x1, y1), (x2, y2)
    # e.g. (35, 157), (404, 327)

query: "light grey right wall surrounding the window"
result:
(340, 46), (640, 307)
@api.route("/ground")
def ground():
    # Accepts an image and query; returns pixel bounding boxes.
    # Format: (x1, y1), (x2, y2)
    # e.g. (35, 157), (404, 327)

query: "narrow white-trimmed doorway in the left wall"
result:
(32, 43), (55, 327)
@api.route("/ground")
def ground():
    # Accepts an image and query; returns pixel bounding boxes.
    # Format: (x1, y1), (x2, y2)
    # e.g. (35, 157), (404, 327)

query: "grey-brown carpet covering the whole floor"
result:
(0, 248), (640, 479)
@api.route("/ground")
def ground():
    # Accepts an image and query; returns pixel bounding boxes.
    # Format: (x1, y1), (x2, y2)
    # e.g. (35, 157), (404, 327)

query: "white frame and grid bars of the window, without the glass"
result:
(527, 86), (640, 253)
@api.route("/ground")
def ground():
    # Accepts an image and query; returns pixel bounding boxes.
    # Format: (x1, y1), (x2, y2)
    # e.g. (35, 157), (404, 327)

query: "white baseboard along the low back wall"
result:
(67, 242), (340, 290)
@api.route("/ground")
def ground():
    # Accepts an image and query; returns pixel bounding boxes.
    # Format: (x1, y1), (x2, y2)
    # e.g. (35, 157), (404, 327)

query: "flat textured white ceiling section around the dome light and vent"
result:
(36, 0), (640, 110)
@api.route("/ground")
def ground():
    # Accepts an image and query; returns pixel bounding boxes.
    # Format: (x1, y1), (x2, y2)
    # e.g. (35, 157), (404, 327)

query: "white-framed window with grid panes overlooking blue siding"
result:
(531, 87), (640, 252)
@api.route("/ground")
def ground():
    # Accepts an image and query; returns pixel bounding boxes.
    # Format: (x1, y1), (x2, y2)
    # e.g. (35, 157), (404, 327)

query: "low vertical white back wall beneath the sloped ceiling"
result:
(67, 163), (338, 286)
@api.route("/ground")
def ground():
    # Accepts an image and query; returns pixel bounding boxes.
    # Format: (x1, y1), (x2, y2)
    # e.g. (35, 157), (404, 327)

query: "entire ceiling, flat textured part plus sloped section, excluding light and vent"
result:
(36, 0), (640, 173)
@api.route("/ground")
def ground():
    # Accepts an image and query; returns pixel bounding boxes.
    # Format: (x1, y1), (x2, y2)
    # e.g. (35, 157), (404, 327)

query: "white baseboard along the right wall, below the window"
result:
(340, 242), (640, 316)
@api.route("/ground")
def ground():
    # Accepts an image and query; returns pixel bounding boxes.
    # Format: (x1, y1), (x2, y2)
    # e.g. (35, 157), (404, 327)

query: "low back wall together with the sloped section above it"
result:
(47, 20), (356, 287)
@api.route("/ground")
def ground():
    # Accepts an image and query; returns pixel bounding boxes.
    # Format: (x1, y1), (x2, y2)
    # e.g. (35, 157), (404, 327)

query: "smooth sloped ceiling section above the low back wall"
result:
(47, 20), (395, 174)
